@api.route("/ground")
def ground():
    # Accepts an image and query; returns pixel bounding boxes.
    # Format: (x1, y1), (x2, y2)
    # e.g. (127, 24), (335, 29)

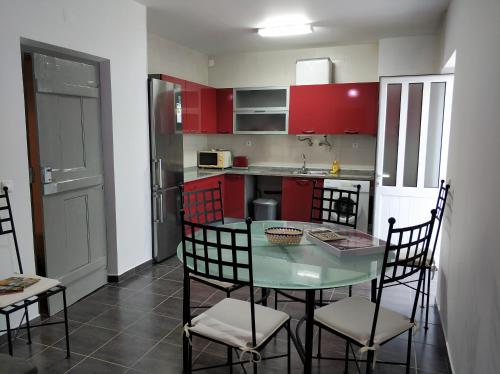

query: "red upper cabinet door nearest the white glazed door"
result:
(331, 82), (379, 135)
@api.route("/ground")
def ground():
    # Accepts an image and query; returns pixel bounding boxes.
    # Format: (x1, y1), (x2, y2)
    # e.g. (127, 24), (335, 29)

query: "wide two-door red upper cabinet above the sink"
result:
(288, 82), (379, 135)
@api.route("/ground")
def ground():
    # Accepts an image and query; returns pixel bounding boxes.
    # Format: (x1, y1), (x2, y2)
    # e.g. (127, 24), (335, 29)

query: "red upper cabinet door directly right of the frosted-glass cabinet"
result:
(288, 84), (332, 134)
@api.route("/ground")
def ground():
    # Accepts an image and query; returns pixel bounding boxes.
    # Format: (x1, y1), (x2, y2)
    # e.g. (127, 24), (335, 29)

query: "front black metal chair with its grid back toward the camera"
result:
(181, 210), (290, 373)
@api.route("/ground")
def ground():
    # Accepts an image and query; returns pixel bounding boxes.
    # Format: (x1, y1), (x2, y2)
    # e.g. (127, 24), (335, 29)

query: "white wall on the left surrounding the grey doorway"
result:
(0, 0), (151, 284)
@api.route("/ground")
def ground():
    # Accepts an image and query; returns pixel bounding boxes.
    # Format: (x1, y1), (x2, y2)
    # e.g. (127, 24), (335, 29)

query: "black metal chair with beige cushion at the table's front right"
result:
(314, 209), (436, 373)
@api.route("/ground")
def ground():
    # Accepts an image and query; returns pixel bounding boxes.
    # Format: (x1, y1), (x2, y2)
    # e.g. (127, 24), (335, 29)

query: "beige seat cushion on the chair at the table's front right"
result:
(314, 296), (413, 346)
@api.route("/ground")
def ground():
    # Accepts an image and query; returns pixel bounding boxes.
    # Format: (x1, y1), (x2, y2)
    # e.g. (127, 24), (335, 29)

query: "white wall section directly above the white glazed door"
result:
(378, 35), (439, 76)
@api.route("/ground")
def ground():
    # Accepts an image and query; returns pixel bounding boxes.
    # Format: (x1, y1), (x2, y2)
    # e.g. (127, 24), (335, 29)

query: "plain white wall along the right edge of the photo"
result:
(438, 0), (500, 374)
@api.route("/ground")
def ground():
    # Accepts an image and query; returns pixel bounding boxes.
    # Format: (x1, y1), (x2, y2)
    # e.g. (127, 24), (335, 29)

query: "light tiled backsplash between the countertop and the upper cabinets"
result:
(184, 135), (376, 170)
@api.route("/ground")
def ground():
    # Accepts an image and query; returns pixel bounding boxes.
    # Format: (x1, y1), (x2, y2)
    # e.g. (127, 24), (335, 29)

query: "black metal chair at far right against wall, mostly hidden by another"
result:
(394, 180), (450, 330)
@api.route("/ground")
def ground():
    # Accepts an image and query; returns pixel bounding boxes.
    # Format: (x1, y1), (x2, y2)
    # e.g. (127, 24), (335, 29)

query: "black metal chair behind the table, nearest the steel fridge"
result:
(180, 181), (244, 297)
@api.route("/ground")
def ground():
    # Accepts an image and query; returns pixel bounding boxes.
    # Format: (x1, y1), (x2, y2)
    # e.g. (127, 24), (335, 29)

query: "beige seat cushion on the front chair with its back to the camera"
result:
(189, 298), (290, 349)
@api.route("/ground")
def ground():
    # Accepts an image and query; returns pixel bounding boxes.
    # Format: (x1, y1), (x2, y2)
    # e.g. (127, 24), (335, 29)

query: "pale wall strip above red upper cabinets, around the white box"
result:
(208, 44), (378, 87)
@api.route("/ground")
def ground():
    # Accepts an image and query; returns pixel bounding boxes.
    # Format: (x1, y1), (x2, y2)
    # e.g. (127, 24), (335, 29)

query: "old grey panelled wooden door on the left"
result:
(33, 54), (107, 314)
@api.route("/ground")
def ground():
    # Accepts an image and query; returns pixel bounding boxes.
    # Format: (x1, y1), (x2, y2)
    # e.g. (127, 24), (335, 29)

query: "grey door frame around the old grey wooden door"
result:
(21, 38), (117, 315)
